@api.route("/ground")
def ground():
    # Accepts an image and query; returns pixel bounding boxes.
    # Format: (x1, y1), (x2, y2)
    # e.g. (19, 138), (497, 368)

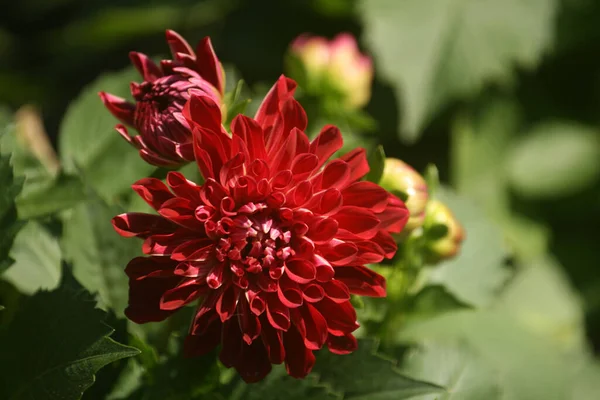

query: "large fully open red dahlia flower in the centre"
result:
(113, 77), (408, 382)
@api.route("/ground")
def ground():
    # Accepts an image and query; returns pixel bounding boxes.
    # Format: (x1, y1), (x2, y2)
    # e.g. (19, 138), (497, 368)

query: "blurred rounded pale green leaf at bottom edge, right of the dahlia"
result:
(402, 342), (501, 400)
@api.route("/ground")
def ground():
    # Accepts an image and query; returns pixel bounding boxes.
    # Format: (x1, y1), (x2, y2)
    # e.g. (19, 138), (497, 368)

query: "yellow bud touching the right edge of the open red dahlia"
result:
(379, 158), (428, 232)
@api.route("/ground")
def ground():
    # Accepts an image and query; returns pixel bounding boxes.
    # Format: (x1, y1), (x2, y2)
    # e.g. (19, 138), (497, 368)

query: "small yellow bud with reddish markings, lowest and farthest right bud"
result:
(425, 200), (465, 263)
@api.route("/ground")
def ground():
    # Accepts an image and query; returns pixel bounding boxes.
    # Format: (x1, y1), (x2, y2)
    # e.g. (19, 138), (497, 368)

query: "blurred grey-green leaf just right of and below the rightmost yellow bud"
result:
(429, 188), (509, 306)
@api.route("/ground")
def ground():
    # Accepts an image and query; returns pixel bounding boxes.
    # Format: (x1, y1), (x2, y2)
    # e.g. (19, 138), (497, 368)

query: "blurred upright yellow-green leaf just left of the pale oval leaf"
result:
(451, 98), (549, 260)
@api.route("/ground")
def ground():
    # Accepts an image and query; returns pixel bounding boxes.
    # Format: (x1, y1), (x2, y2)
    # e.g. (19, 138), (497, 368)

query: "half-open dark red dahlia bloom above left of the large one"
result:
(99, 30), (225, 167)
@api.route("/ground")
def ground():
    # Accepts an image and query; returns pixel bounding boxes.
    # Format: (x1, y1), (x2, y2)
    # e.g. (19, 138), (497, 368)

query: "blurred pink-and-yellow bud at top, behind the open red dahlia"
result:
(290, 33), (373, 109)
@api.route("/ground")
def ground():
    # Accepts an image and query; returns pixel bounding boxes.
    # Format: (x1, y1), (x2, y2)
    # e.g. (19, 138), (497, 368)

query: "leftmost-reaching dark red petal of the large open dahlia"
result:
(111, 213), (175, 238)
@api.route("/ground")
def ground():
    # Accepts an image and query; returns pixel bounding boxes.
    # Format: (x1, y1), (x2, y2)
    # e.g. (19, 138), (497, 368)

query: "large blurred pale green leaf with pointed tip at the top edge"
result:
(361, 0), (557, 142)
